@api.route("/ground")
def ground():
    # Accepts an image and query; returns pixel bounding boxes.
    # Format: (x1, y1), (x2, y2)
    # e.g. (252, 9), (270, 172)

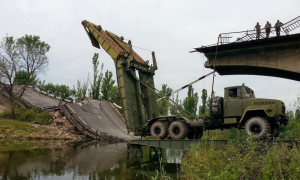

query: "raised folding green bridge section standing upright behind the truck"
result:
(82, 20), (159, 133)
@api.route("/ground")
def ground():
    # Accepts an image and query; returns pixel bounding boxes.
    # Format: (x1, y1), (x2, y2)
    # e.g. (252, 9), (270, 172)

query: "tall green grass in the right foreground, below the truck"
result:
(181, 139), (300, 180)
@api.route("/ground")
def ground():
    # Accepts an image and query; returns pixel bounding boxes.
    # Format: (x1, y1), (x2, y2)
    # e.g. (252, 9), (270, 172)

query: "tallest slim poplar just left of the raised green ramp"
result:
(90, 53), (104, 99)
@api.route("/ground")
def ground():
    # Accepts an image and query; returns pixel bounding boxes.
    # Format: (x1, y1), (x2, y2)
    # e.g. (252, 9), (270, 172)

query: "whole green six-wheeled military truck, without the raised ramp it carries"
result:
(143, 85), (288, 140)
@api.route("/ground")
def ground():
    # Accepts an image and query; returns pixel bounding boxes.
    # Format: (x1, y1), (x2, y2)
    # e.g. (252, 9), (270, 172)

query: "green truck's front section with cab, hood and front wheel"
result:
(209, 85), (288, 139)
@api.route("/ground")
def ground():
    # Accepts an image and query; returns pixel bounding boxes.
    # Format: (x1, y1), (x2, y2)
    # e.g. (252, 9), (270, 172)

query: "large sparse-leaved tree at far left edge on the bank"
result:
(0, 35), (50, 118)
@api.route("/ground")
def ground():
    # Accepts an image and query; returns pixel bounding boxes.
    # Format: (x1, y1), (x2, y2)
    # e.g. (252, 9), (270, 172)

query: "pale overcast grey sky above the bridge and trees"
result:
(0, 0), (300, 108)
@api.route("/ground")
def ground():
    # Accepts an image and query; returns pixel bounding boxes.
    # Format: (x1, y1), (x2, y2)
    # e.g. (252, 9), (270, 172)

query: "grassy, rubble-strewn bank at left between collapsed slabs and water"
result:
(0, 107), (85, 141)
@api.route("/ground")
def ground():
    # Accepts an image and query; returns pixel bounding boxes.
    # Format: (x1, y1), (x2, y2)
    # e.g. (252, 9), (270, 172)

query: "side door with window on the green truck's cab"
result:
(224, 87), (243, 117)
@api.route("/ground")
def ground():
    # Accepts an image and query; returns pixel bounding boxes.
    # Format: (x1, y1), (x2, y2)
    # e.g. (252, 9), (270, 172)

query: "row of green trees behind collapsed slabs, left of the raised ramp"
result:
(15, 53), (121, 104)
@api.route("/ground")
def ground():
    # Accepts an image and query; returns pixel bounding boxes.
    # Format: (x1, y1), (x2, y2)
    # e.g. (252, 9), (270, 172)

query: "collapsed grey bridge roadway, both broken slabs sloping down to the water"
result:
(7, 86), (134, 142)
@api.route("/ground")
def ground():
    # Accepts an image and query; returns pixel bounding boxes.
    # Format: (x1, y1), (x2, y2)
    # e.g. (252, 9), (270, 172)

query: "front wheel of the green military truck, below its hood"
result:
(245, 117), (271, 140)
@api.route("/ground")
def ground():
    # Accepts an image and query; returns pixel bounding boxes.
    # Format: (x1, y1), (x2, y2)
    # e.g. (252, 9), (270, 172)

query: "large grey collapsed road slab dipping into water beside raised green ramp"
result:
(59, 100), (134, 142)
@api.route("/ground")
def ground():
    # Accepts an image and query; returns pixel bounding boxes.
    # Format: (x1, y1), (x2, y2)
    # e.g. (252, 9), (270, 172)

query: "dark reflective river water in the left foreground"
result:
(0, 141), (183, 180)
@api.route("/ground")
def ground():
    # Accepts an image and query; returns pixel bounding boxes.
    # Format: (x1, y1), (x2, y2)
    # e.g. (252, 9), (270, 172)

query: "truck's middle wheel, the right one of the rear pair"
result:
(169, 121), (188, 139)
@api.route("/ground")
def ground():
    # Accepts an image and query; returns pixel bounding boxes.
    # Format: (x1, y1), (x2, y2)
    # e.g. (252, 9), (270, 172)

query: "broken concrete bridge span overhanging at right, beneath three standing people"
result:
(195, 34), (300, 81)
